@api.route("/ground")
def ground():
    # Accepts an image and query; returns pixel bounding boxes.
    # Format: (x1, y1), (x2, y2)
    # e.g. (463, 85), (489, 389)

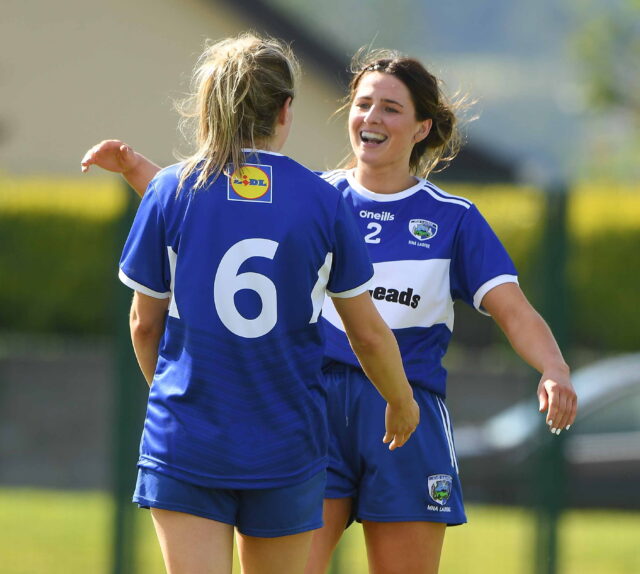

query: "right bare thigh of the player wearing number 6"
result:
(237, 531), (313, 574)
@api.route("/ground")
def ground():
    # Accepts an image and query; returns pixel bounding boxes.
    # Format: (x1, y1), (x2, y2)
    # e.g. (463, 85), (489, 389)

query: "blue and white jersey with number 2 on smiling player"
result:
(322, 170), (517, 396)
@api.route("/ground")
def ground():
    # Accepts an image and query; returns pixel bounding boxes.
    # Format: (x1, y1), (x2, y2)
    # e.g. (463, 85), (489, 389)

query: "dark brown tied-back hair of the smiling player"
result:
(341, 49), (468, 178)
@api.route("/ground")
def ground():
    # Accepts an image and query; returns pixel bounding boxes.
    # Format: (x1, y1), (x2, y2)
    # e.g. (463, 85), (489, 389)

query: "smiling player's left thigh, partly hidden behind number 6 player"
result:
(305, 498), (352, 574)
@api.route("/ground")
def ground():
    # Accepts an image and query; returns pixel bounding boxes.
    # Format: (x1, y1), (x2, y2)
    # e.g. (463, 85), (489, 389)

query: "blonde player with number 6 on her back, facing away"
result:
(82, 34), (419, 574)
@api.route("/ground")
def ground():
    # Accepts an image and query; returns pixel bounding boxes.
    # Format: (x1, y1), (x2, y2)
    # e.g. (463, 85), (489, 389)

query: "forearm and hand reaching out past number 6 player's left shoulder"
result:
(80, 140), (160, 197)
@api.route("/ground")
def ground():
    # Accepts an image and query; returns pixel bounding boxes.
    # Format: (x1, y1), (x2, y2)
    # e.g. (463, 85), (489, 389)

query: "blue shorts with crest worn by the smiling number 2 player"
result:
(325, 363), (467, 526)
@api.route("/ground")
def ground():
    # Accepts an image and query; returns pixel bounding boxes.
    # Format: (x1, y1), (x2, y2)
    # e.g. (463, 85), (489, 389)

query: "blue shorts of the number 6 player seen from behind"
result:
(133, 468), (326, 538)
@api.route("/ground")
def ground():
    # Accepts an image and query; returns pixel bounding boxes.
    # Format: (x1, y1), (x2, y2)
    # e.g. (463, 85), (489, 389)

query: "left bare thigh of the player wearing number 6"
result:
(151, 508), (233, 574)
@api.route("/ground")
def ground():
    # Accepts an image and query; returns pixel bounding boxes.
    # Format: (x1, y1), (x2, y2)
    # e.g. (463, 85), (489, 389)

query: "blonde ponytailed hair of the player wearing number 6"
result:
(176, 33), (300, 189)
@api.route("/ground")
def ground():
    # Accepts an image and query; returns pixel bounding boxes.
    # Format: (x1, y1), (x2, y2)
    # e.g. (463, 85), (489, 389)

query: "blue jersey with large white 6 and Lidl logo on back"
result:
(120, 152), (373, 488)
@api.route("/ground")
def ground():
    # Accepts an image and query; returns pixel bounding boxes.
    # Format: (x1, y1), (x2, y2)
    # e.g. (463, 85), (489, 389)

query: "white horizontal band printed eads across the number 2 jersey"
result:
(322, 259), (453, 331)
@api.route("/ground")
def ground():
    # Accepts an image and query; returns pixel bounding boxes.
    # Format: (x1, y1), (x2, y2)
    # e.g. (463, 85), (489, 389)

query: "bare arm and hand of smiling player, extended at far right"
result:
(482, 283), (577, 434)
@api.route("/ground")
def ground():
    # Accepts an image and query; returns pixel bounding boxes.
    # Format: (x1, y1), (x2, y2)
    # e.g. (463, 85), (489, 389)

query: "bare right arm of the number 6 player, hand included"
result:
(333, 292), (420, 450)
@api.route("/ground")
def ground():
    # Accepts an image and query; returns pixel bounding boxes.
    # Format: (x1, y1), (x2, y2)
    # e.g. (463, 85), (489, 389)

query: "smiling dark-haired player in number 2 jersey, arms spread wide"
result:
(85, 45), (576, 574)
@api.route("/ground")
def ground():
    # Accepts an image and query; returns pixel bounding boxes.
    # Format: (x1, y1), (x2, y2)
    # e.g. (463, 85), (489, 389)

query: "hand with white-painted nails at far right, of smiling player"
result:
(538, 371), (578, 435)
